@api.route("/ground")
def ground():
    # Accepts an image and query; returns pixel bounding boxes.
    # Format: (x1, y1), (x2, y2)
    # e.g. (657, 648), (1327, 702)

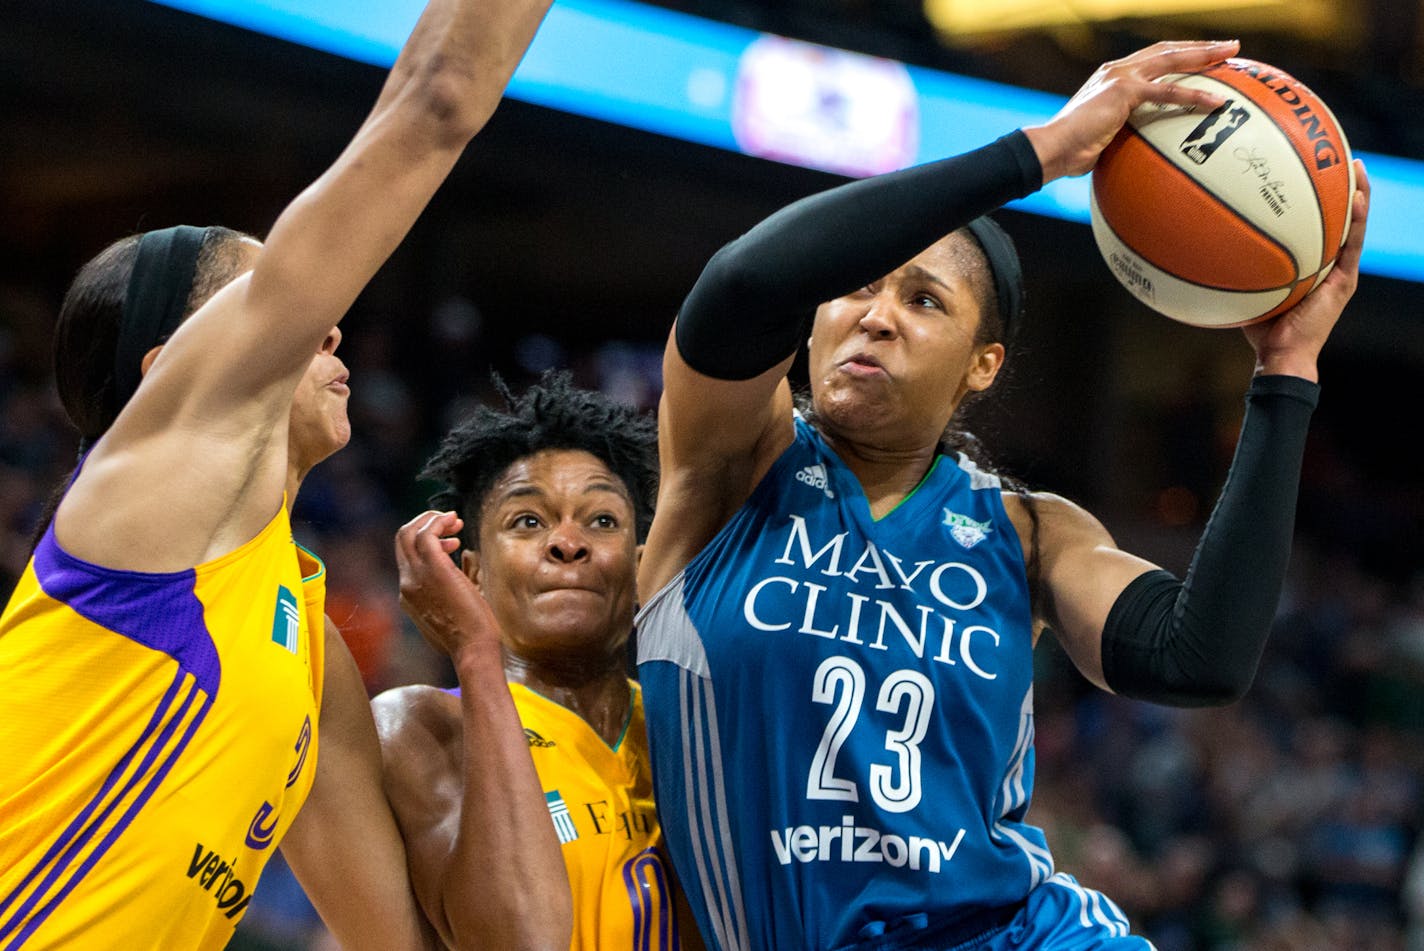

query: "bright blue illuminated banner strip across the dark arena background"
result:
(152, 0), (1424, 282)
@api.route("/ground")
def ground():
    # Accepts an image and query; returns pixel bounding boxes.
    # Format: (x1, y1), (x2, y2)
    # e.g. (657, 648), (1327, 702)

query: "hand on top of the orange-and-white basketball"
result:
(1024, 40), (1240, 184)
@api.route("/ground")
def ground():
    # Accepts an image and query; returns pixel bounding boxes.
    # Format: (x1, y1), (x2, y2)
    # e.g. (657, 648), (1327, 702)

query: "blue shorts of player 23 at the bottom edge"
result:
(844, 873), (1155, 951)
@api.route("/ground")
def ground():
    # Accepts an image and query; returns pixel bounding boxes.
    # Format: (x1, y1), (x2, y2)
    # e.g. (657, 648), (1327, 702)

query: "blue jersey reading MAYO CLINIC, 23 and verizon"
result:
(638, 419), (1054, 950)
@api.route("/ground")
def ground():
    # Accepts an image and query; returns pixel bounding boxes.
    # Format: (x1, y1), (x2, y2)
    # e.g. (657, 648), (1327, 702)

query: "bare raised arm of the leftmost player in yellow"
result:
(115, 0), (551, 455)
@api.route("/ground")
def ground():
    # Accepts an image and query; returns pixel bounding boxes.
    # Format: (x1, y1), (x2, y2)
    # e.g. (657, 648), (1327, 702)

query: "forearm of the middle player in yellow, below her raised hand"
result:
(443, 653), (574, 951)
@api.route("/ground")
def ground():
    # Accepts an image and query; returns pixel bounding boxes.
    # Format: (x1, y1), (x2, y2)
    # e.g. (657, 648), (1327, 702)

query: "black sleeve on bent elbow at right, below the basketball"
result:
(1102, 376), (1320, 706)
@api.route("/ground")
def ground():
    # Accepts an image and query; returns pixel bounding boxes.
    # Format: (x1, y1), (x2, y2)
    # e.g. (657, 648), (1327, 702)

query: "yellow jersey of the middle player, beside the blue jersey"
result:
(510, 682), (681, 951)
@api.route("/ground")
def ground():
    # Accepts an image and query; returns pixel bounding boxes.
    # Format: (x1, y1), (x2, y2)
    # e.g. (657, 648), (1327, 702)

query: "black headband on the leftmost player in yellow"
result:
(114, 225), (208, 409)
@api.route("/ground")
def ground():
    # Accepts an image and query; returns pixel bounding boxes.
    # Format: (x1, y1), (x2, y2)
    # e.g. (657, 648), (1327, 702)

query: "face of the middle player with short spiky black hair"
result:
(473, 450), (638, 663)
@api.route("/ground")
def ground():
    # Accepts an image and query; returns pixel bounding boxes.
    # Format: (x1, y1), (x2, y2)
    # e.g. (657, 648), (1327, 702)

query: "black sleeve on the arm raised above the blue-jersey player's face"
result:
(675, 131), (1042, 380)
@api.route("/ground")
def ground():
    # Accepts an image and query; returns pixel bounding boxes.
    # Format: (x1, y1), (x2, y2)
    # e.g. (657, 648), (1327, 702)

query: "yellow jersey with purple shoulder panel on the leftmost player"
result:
(0, 505), (326, 951)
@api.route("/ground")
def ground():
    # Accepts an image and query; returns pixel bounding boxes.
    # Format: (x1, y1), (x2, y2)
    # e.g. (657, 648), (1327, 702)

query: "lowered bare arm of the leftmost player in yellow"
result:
(282, 619), (441, 951)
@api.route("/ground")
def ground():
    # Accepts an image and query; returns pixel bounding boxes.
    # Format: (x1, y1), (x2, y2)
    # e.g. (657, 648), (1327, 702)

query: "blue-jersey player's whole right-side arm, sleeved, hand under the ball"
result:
(1041, 167), (1368, 706)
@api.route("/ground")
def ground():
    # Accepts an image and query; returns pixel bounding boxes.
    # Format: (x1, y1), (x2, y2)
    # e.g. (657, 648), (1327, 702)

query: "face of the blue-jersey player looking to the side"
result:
(810, 233), (1004, 446)
